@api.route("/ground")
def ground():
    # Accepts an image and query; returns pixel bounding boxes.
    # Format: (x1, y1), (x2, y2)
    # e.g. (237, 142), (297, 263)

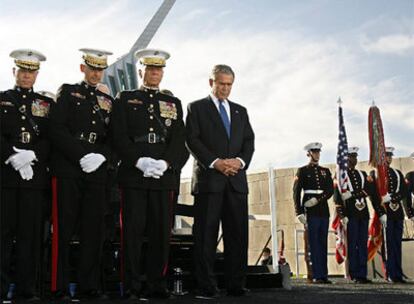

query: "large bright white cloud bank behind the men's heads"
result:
(0, 2), (414, 176)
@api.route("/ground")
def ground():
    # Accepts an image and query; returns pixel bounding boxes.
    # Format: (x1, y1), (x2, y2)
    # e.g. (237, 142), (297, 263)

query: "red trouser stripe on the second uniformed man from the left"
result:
(50, 176), (59, 292)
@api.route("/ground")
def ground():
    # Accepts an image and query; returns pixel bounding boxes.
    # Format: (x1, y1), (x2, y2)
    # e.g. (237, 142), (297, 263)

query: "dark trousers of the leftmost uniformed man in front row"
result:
(1, 187), (45, 299)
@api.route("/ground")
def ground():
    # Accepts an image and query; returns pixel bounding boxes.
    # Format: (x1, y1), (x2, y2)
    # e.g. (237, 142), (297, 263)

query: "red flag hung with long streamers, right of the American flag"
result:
(368, 104), (388, 262)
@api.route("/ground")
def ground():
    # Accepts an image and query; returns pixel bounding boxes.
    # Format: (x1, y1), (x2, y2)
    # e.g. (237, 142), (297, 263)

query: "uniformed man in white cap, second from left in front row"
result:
(50, 49), (113, 298)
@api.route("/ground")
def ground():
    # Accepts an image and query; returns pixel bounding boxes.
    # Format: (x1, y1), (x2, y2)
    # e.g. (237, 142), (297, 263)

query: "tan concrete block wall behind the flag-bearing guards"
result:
(180, 158), (414, 277)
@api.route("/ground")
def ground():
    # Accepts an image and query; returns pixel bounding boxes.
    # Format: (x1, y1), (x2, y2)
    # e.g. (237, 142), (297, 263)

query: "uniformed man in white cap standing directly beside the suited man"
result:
(111, 49), (185, 298)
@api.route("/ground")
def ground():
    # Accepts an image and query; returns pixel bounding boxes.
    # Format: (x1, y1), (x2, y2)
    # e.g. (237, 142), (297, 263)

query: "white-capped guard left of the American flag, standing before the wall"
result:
(293, 142), (333, 284)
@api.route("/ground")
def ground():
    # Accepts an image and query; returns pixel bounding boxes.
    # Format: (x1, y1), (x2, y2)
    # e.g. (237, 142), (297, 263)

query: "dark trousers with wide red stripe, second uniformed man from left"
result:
(53, 177), (106, 293)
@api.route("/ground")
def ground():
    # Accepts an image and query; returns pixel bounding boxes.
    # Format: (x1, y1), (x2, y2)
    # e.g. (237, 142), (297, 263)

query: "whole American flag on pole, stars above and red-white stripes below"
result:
(332, 99), (349, 264)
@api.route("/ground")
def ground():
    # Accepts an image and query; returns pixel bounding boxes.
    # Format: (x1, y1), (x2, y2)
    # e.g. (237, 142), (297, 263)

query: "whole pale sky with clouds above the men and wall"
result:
(0, 0), (414, 176)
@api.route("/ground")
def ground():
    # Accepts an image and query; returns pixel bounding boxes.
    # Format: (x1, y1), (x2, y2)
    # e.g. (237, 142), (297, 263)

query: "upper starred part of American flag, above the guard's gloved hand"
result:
(336, 99), (349, 192)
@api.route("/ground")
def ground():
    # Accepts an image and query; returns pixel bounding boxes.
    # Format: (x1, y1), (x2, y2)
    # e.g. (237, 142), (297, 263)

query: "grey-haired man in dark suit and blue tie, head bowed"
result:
(186, 65), (254, 298)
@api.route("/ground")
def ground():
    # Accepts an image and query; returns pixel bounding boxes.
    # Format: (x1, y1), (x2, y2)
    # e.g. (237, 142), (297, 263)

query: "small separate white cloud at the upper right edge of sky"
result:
(361, 34), (414, 55)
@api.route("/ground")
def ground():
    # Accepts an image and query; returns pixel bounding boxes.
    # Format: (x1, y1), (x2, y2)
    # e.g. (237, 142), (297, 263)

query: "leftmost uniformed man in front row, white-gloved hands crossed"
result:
(0, 49), (53, 300)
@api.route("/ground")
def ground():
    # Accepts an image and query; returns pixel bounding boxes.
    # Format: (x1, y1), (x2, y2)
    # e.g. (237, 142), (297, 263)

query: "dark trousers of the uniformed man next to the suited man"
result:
(121, 187), (173, 294)
